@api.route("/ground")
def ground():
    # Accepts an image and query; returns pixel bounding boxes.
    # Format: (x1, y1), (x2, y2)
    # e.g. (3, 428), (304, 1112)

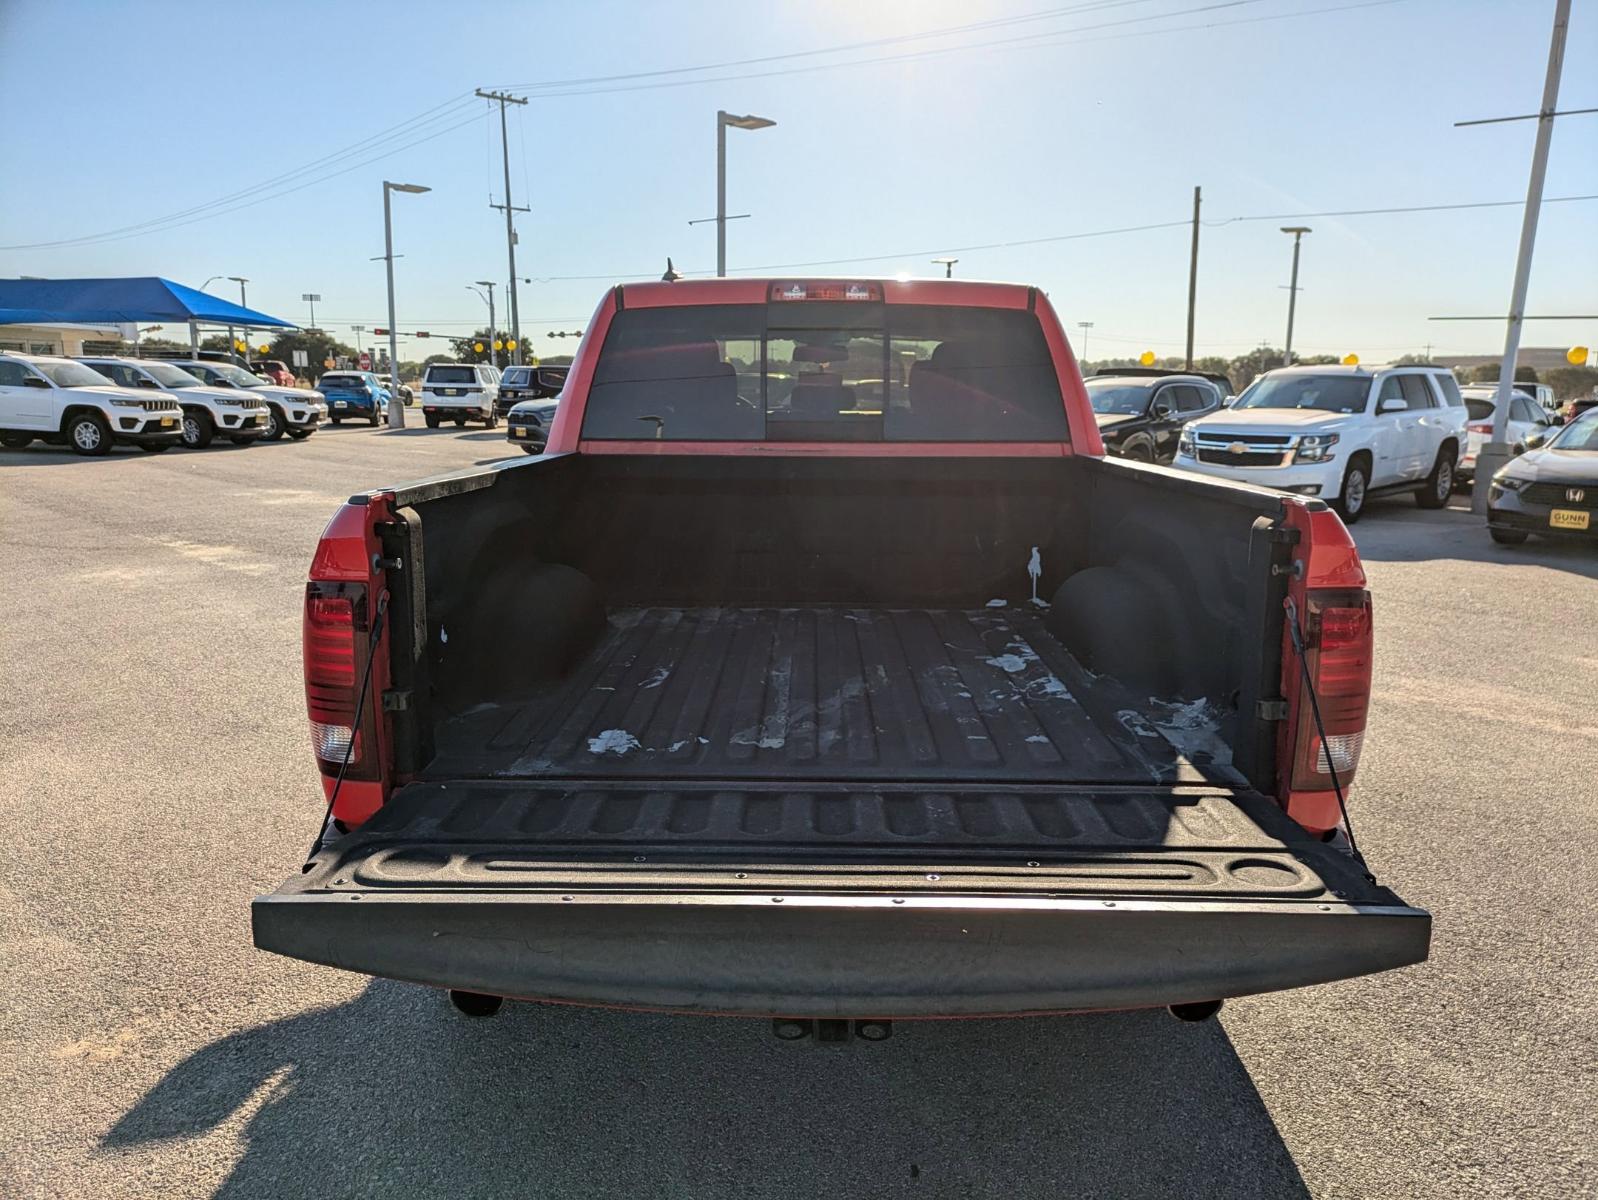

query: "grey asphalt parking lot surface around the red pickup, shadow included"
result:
(0, 427), (1598, 1200)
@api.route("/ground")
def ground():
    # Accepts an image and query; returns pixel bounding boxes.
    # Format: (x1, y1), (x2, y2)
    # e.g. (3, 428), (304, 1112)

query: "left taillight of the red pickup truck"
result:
(304, 582), (379, 780)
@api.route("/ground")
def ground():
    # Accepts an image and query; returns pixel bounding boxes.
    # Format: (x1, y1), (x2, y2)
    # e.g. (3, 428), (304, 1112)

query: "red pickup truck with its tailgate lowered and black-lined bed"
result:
(252, 280), (1430, 1026)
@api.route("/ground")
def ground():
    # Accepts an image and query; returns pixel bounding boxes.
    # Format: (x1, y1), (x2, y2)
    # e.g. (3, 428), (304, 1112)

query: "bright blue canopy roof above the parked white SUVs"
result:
(0, 275), (297, 329)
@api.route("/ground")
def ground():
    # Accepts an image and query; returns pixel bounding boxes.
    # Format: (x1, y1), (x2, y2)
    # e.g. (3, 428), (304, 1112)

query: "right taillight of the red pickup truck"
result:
(1291, 588), (1374, 796)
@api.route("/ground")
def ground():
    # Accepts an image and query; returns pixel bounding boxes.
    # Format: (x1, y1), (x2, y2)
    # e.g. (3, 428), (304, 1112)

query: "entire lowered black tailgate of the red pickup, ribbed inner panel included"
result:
(252, 781), (1432, 1018)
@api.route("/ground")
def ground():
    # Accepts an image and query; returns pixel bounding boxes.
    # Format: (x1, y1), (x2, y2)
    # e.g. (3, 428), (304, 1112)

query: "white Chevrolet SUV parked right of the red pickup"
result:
(1173, 366), (1467, 524)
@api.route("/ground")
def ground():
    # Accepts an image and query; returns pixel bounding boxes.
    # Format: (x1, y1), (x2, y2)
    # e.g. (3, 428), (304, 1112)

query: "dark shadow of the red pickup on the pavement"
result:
(102, 981), (1309, 1200)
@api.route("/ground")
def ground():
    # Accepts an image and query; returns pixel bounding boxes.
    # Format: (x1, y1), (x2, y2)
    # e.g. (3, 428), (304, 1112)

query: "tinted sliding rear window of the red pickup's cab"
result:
(583, 302), (1069, 443)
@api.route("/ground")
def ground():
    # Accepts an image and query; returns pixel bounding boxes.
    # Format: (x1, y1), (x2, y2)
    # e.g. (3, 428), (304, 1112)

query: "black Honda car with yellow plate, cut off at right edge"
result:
(1488, 409), (1598, 545)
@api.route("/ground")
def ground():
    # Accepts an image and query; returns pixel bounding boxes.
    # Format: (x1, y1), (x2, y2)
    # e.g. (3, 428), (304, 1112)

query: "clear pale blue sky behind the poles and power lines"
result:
(0, 0), (1598, 361)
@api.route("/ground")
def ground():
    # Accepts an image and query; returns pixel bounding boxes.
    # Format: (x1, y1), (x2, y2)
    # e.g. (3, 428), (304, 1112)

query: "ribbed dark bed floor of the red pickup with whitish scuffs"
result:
(425, 604), (1242, 785)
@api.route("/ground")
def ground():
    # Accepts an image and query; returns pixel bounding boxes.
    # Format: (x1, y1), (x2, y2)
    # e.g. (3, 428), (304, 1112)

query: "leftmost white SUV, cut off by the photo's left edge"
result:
(0, 352), (181, 455)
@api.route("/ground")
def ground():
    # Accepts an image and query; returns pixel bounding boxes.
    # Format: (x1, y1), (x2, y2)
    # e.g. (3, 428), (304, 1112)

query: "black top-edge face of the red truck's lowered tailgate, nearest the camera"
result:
(252, 890), (1432, 1018)
